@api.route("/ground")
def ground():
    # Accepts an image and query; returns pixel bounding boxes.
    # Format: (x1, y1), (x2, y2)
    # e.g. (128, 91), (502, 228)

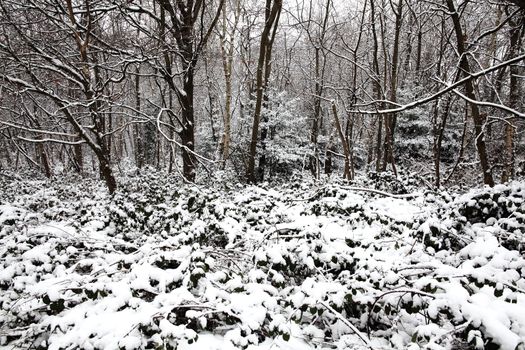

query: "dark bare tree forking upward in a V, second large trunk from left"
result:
(125, 0), (225, 182)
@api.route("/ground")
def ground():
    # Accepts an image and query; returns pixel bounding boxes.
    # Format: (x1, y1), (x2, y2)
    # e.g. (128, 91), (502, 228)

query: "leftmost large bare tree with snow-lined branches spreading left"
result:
(0, 0), (133, 193)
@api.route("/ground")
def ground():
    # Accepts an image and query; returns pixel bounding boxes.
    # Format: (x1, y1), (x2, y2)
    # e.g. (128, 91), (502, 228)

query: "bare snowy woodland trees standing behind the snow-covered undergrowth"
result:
(0, 0), (525, 186)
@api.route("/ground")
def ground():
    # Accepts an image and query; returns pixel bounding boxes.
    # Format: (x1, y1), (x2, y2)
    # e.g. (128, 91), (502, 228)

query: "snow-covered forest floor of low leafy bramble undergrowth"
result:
(0, 174), (525, 350)
